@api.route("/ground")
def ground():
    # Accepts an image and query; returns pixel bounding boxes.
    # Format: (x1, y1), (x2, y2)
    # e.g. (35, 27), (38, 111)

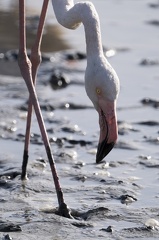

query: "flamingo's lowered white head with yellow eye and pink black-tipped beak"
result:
(85, 58), (119, 163)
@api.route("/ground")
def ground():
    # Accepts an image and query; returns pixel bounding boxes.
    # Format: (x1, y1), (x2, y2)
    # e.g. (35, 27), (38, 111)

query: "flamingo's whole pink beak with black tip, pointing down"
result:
(96, 100), (118, 163)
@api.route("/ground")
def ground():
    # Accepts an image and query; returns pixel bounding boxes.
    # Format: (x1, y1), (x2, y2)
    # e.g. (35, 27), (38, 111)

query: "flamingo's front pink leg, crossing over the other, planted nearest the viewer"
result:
(18, 0), (72, 218)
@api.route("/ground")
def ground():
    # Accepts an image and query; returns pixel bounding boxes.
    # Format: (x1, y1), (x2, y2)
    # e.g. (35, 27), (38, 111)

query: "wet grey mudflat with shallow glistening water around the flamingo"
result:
(0, 1), (159, 240)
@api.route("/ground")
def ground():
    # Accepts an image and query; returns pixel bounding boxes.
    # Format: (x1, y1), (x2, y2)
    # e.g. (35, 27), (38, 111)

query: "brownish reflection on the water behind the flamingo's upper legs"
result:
(0, 1), (69, 52)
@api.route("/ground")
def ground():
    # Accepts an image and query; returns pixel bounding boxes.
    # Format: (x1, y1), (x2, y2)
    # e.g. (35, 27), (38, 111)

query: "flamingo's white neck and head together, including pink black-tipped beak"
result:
(52, 0), (119, 162)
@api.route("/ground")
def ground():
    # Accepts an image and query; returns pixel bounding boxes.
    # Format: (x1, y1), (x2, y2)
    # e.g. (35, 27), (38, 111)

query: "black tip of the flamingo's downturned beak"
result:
(96, 141), (115, 163)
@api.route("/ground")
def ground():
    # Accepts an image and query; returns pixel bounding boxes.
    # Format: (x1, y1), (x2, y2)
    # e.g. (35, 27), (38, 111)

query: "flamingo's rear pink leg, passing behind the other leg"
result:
(21, 0), (49, 180)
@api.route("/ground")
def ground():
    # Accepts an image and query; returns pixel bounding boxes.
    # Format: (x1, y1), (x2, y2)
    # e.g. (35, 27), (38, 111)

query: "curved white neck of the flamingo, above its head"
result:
(52, 0), (103, 61)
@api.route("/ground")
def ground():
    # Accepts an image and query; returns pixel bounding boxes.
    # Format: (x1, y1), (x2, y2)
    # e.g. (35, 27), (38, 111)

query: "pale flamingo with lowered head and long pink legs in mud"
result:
(18, 0), (119, 218)
